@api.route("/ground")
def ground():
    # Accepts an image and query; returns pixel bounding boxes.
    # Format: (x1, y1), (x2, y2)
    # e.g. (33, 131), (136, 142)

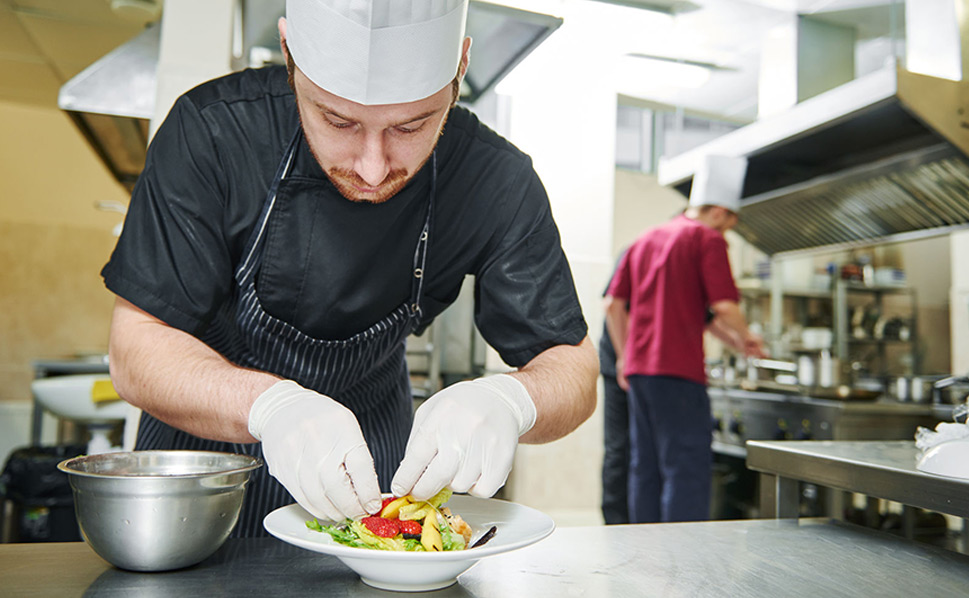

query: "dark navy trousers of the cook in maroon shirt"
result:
(628, 375), (713, 523)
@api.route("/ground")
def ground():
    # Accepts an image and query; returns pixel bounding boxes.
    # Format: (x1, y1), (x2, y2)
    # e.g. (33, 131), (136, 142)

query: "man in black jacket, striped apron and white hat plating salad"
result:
(102, 0), (597, 536)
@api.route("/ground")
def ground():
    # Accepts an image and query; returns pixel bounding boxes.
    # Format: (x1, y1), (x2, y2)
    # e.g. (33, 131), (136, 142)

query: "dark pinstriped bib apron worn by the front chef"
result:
(136, 128), (437, 537)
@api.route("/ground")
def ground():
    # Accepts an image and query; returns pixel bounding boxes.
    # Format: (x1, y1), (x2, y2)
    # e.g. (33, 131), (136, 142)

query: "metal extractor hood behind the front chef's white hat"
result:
(57, 0), (562, 191)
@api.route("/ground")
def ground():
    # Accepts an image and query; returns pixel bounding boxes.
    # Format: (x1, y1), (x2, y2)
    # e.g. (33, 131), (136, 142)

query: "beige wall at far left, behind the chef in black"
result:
(0, 102), (128, 401)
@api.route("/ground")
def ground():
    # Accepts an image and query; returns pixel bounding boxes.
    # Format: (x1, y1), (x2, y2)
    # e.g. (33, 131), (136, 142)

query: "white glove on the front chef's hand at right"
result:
(391, 374), (536, 500)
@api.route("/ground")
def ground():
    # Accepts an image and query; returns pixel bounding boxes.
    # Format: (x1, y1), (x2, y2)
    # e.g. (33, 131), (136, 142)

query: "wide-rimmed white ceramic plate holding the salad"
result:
(263, 495), (555, 592)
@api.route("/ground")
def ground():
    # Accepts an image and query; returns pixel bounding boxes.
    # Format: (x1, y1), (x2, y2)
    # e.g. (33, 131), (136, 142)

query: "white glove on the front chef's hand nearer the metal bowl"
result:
(249, 380), (381, 521)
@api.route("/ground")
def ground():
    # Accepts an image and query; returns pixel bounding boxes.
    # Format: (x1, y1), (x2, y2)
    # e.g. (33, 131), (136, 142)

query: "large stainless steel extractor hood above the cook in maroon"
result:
(658, 6), (969, 255)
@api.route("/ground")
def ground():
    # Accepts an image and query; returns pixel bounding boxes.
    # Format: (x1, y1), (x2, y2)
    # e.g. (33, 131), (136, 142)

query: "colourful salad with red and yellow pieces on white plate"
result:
(306, 488), (494, 552)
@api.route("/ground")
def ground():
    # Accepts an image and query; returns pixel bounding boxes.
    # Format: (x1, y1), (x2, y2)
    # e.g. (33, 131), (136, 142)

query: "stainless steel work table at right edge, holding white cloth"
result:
(747, 440), (969, 518)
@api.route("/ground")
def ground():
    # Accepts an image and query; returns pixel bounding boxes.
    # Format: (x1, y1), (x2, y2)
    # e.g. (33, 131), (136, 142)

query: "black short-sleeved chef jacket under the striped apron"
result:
(102, 67), (587, 366)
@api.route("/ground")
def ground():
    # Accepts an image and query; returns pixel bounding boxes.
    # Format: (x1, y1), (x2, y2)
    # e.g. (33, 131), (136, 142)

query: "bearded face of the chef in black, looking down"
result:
(284, 25), (467, 203)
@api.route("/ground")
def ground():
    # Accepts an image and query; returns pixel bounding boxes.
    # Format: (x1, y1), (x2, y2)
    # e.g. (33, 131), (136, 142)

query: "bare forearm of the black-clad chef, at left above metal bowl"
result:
(109, 298), (279, 442)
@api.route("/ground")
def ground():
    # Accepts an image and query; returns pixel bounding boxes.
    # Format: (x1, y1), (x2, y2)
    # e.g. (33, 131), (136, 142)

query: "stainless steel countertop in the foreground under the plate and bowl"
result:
(0, 519), (969, 598)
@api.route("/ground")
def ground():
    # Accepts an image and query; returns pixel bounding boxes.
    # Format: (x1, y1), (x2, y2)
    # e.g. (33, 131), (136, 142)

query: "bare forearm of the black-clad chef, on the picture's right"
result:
(511, 336), (599, 444)
